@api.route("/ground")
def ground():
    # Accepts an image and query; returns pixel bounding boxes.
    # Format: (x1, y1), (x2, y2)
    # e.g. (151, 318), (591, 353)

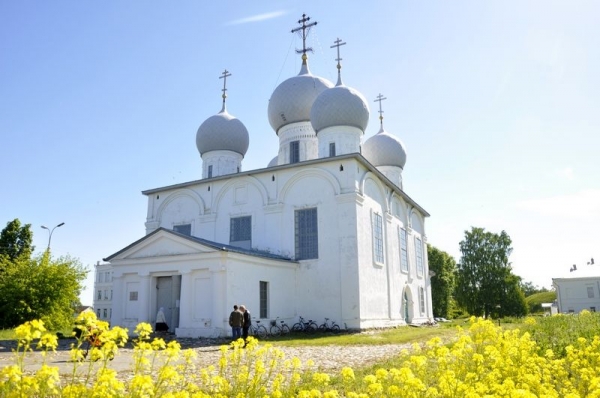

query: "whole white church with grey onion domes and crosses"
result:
(94, 16), (433, 337)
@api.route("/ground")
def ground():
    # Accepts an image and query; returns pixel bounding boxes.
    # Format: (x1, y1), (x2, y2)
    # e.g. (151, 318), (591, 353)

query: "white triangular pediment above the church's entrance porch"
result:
(106, 230), (216, 261)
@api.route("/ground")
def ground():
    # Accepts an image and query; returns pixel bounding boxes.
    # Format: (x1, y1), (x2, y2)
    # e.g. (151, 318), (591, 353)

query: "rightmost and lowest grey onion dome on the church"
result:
(362, 126), (406, 169)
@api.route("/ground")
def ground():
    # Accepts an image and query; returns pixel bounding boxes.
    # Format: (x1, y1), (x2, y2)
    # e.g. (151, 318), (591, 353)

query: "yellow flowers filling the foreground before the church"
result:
(0, 312), (600, 398)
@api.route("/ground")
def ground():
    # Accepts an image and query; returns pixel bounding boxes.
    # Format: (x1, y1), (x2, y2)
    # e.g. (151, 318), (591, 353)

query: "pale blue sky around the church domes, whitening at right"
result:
(0, 0), (600, 304)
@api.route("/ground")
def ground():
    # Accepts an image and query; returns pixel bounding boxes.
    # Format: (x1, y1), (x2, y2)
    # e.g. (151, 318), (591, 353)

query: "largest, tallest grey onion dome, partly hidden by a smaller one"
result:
(268, 64), (333, 132)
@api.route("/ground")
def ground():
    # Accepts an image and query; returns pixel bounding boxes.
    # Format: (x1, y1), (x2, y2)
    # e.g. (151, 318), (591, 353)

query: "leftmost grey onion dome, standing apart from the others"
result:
(196, 109), (250, 156)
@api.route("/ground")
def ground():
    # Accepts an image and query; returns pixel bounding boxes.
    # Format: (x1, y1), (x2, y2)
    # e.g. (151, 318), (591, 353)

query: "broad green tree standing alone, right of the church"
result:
(455, 227), (527, 318)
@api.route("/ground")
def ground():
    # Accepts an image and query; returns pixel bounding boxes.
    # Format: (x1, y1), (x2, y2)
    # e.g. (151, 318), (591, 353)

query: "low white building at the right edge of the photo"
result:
(552, 259), (600, 314)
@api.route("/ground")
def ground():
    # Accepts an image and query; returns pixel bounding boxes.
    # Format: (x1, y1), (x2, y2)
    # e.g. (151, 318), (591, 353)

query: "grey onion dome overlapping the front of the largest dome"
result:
(310, 85), (369, 133)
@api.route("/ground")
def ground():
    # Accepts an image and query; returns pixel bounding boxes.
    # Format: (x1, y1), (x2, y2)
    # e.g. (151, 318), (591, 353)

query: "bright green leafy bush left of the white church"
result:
(0, 252), (88, 330)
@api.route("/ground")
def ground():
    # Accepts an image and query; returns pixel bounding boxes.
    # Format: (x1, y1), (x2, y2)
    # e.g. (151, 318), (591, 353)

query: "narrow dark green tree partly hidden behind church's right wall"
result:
(427, 245), (456, 318)
